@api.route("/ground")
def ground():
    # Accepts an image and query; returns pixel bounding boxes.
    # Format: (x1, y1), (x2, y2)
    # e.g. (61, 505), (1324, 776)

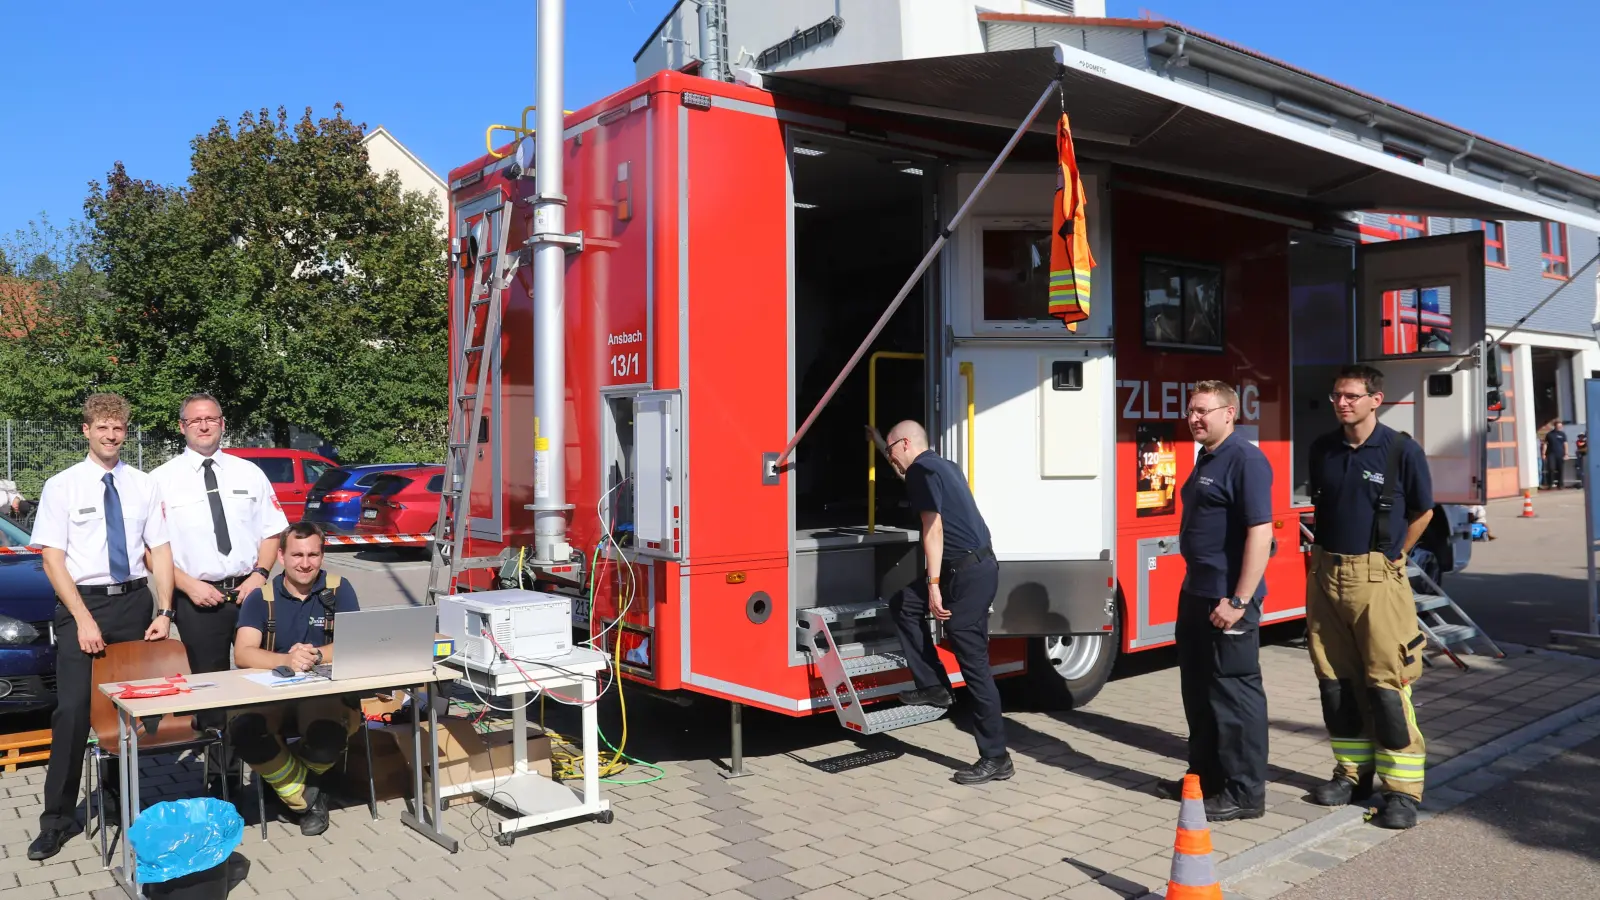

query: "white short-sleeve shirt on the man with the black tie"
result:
(150, 448), (290, 581)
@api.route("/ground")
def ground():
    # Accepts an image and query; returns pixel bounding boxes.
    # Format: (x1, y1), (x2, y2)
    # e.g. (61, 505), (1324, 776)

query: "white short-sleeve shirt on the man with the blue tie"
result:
(34, 456), (166, 585)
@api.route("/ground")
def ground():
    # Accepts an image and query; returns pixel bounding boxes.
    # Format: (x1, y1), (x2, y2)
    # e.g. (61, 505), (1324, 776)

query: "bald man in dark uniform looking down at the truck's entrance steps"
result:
(869, 421), (1014, 785)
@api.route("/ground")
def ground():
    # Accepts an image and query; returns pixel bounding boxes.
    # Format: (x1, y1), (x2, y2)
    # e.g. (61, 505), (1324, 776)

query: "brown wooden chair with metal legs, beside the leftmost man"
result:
(83, 641), (227, 866)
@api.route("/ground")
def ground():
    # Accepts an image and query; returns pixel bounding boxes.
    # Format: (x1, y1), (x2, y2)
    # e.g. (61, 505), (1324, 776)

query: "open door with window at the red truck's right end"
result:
(1355, 231), (1498, 506)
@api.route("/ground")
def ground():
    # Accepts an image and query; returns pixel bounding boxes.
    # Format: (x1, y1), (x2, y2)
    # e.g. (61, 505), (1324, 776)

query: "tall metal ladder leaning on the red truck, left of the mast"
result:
(427, 200), (522, 604)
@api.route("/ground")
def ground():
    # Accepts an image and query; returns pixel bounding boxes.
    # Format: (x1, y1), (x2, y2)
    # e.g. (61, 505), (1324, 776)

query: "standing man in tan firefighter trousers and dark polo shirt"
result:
(1306, 365), (1434, 828)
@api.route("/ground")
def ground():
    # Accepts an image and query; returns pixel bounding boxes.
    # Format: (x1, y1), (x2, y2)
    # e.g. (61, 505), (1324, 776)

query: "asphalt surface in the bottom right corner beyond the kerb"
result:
(1275, 740), (1600, 900)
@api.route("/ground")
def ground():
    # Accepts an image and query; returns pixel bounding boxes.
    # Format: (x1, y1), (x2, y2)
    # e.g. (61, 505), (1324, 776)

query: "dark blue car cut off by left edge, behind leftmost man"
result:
(0, 519), (56, 716)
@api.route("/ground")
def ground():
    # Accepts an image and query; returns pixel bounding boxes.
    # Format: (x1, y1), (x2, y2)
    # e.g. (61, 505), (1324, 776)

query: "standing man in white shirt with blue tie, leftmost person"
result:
(27, 394), (173, 860)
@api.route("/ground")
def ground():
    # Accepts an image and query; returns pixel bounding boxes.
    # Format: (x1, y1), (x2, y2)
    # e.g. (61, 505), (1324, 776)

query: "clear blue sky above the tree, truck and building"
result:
(0, 0), (1600, 234)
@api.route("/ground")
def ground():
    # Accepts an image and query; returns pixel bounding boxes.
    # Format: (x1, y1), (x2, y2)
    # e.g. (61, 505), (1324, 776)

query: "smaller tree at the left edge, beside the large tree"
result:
(0, 216), (115, 423)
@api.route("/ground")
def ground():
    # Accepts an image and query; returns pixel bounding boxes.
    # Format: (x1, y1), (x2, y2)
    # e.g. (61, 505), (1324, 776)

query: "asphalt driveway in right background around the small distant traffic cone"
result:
(1443, 488), (1589, 647)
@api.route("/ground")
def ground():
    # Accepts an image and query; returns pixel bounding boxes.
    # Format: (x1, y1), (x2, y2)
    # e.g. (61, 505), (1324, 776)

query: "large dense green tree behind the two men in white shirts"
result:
(85, 106), (448, 460)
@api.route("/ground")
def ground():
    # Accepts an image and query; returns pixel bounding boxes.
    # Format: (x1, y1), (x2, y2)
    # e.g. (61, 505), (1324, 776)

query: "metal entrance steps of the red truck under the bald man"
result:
(795, 601), (946, 735)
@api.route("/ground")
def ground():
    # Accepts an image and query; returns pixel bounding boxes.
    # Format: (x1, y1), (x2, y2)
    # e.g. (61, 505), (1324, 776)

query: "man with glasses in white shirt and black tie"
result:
(150, 394), (290, 790)
